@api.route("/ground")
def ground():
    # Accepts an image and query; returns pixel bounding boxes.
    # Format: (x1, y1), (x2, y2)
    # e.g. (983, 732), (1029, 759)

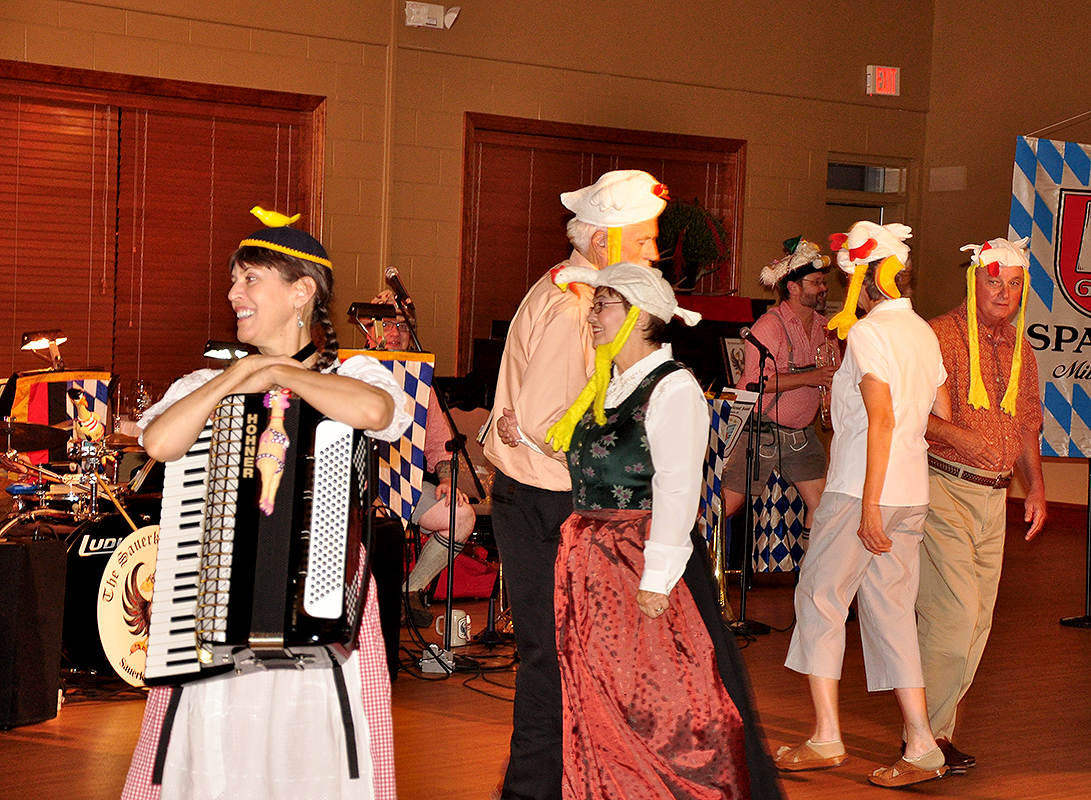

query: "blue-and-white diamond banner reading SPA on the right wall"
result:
(1008, 136), (1091, 451)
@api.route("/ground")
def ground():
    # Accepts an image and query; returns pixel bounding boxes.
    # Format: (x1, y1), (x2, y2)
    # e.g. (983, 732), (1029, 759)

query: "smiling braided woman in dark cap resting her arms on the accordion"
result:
(122, 217), (409, 800)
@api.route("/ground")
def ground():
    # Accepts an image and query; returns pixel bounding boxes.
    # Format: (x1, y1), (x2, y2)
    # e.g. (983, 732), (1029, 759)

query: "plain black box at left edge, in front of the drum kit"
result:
(0, 540), (65, 730)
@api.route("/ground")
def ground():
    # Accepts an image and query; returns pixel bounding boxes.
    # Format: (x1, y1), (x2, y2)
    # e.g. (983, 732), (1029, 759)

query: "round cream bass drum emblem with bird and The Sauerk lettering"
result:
(98, 525), (159, 686)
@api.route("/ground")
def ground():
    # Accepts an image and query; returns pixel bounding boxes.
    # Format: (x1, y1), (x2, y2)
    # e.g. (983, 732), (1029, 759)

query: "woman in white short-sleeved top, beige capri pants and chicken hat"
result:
(776, 220), (949, 788)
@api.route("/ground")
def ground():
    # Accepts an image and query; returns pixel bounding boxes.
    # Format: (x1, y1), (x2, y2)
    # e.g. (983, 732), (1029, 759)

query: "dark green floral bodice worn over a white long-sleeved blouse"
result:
(568, 361), (684, 511)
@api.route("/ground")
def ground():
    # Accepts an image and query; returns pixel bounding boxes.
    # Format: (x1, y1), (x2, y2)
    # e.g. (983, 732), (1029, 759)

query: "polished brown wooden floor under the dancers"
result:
(0, 505), (1091, 800)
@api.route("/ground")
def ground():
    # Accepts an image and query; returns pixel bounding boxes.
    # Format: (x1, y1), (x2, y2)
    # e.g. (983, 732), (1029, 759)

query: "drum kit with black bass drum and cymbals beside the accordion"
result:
(0, 401), (159, 685)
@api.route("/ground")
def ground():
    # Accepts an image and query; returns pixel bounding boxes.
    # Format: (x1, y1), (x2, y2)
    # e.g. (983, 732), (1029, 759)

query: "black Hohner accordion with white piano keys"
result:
(145, 394), (374, 683)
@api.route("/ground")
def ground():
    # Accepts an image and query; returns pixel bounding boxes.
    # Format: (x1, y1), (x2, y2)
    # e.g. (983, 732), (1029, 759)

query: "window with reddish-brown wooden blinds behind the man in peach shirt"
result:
(458, 114), (745, 374)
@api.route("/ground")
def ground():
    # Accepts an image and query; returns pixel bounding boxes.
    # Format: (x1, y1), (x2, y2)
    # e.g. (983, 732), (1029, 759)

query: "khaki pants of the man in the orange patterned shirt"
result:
(916, 468), (1007, 741)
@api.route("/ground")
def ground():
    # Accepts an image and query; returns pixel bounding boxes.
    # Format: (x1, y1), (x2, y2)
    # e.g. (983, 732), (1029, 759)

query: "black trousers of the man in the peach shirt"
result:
(492, 469), (572, 800)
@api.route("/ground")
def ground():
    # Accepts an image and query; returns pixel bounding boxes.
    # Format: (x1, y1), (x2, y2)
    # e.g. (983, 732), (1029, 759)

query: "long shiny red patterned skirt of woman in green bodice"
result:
(554, 511), (750, 800)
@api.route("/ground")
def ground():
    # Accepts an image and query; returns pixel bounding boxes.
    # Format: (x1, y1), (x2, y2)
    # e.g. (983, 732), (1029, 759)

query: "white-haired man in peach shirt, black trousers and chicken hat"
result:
(484, 169), (667, 800)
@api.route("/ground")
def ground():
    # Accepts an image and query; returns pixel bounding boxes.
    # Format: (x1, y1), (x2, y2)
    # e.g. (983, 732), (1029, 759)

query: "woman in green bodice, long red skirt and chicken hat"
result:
(550, 263), (781, 800)
